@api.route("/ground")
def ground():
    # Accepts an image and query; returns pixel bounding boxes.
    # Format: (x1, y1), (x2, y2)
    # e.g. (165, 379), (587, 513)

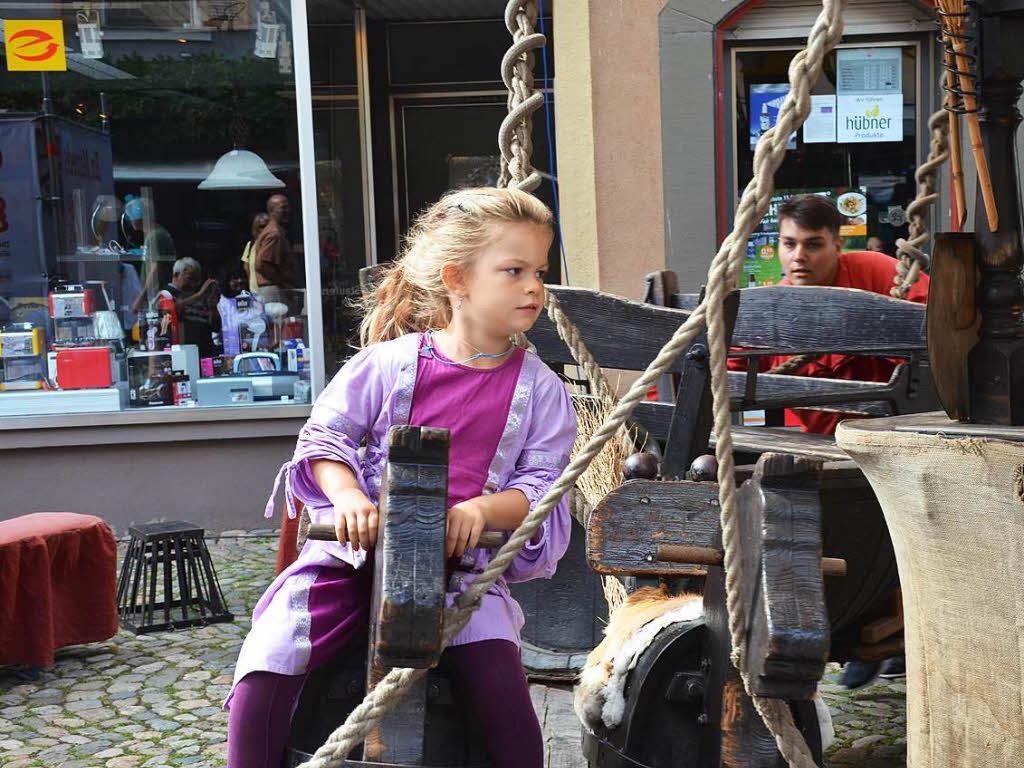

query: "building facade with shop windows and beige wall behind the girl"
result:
(0, 0), (966, 530)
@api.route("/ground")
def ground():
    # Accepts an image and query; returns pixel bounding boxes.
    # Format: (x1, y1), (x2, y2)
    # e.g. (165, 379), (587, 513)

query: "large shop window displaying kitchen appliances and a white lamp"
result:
(0, 0), (315, 416)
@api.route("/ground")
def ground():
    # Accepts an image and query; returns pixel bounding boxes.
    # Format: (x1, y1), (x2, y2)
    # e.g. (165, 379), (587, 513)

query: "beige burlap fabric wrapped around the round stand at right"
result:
(836, 415), (1024, 768)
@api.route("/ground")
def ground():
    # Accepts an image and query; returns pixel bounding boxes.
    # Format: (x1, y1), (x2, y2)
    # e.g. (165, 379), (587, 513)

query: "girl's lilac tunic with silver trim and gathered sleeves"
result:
(234, 334), (575, 696)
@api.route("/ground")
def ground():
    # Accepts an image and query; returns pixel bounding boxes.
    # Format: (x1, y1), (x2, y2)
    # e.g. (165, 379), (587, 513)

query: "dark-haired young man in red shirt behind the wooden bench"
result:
(741, 195), (928, 434)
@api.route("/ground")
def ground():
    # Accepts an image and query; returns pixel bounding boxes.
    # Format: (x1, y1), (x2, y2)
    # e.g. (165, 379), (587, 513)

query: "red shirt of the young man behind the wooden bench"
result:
(729, 251), (928, 434)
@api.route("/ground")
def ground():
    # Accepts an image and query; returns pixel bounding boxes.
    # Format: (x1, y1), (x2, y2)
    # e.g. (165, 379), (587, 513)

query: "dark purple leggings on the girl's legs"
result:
(227, 640), (544, 768)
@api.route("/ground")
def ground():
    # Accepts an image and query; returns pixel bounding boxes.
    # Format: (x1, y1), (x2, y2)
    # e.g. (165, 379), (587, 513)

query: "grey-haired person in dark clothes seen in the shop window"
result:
(156, 256), (220, 357)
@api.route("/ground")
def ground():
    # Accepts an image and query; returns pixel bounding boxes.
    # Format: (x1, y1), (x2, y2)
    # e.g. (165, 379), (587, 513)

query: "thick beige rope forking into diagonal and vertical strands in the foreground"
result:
(305, 0), (846, 768)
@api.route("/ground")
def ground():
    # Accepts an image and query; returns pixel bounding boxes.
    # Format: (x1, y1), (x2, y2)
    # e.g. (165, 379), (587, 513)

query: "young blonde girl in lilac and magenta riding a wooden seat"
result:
(228, 188), (575, 768)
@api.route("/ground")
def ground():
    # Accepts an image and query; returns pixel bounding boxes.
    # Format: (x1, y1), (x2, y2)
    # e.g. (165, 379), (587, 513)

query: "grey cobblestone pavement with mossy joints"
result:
(0, 536), (905, 768)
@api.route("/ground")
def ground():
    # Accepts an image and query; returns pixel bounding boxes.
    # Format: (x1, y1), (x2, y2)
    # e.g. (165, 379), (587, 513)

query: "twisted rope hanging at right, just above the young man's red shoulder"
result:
(890, 110), (949, 299)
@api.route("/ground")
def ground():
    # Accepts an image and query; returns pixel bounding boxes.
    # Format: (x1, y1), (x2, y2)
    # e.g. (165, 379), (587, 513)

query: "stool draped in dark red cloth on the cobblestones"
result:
(0, 512), (118, 667)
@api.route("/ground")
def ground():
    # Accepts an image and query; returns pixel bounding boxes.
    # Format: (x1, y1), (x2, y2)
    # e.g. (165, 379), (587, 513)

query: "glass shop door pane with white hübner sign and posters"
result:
(732, 42), (921, 286)
